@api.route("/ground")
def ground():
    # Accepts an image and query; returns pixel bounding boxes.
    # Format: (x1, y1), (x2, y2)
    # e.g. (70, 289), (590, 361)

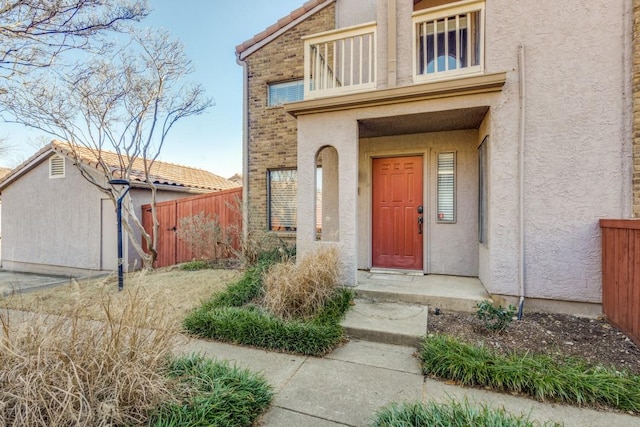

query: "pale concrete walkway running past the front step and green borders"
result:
(180, 340), (640, 427)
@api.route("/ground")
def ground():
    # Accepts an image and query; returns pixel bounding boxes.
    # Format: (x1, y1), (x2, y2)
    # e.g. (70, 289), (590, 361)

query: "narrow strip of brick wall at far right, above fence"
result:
(632, 0), (640, 218)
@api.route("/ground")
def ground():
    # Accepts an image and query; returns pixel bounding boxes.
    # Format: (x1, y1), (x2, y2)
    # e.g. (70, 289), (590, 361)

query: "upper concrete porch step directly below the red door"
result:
(355, 273), (490, 312)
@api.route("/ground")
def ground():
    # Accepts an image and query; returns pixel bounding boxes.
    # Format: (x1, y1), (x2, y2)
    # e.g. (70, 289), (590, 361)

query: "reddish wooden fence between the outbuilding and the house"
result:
(142, 187), (242, 267)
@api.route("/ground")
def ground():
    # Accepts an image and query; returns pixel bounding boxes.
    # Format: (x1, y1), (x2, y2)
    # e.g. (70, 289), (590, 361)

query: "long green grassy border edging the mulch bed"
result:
(420, 335), (640, 412)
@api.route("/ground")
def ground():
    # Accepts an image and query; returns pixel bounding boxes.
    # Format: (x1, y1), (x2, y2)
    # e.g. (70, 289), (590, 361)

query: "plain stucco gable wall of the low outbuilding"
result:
(2, 160), (101, 272)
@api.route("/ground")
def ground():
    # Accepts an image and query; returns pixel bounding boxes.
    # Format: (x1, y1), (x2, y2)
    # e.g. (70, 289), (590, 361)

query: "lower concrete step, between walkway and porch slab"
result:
(342, 298), (428, 347)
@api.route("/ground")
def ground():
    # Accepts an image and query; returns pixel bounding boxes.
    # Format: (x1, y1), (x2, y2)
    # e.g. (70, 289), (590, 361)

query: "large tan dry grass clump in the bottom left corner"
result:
(0, 292), (180, 427)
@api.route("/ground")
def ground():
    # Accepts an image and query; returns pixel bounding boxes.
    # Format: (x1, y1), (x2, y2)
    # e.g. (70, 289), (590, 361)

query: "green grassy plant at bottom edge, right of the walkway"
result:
(371, 400), (557, 427)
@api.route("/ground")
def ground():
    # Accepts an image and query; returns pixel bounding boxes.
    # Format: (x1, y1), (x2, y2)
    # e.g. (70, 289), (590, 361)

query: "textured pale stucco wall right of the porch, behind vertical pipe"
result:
(486, 0), (631, 302)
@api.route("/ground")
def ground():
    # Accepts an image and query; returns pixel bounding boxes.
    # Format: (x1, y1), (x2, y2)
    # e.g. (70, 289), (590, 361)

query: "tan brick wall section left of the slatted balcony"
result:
(245, 3), (335, 242)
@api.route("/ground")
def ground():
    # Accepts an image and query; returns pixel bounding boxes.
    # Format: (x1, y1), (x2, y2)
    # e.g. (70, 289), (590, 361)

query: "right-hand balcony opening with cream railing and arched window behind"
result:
(413, 0), (484, 83)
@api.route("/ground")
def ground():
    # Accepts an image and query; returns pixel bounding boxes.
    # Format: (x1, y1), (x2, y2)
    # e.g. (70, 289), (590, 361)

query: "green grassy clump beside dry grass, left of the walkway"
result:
(149, 356), (273, 427)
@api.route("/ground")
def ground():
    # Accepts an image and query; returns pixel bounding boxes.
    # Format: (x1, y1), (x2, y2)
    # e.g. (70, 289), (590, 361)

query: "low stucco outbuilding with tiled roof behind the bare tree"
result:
(0, 141), (237, 275)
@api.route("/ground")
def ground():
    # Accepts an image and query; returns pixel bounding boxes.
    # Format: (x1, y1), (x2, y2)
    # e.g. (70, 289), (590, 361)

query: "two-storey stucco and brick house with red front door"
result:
(236, 0), (640, 311)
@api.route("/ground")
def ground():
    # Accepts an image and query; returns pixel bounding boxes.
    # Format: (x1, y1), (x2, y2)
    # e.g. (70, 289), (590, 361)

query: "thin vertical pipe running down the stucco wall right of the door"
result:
(518, 44), (527, 320)
